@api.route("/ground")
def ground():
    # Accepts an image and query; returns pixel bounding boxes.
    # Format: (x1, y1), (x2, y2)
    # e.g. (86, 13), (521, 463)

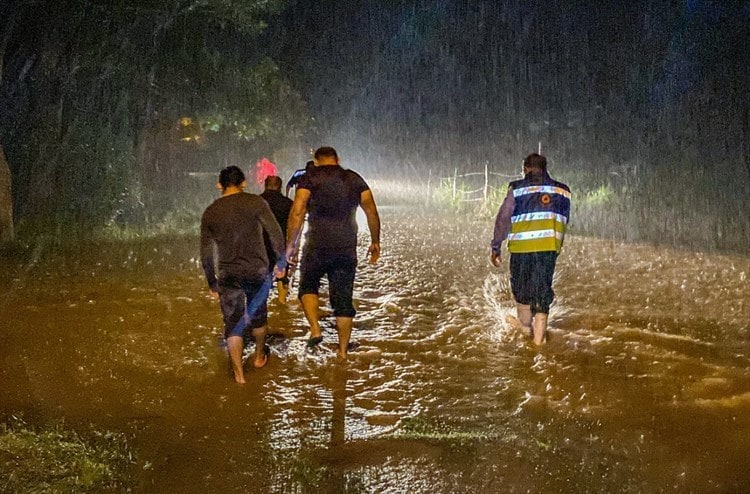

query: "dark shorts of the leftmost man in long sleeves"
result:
(219, 280), (268, 338)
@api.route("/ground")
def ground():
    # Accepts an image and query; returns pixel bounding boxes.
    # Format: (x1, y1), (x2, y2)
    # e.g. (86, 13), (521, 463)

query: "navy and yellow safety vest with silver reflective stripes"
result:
(508, 173), (570, 254)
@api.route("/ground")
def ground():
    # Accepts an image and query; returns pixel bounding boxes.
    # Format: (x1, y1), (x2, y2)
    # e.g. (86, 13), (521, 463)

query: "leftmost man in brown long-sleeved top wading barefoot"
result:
(201, 166), (286, 383)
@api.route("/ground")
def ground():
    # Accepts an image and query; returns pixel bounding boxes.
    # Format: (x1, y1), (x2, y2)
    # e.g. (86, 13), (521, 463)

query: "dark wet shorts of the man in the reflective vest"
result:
(510, 252), (557, 314)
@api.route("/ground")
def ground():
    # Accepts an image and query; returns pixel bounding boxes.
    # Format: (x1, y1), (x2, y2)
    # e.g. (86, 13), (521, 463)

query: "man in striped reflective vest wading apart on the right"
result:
(491, 153), (570, 345)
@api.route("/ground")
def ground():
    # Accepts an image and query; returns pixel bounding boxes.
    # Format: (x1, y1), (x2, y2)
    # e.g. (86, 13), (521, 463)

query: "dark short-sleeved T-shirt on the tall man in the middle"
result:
(299, 165), (368, 250)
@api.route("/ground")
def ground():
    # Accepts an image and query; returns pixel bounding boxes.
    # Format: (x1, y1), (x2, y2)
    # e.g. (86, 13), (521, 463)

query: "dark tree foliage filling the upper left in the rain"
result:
(0, 0), (307, 228)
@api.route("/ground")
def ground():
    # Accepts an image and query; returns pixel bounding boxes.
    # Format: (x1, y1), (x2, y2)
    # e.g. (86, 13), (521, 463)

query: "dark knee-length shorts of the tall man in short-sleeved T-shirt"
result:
(299, 250), (357, 317)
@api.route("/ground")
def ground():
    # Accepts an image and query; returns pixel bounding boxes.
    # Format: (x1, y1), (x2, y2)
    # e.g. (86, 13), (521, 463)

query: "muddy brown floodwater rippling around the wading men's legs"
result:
(0, 208), (750, 493)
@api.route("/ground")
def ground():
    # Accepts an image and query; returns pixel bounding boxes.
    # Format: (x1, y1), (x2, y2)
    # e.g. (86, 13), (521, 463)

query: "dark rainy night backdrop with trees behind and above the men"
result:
(0, 0), (750, 252)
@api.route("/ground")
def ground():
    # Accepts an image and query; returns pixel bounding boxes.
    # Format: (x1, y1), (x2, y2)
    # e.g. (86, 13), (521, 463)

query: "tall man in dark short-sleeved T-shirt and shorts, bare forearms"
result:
(286, 147), (380, 358)
